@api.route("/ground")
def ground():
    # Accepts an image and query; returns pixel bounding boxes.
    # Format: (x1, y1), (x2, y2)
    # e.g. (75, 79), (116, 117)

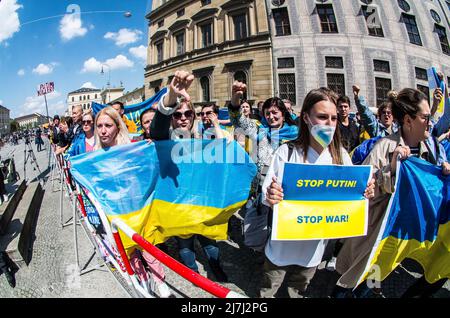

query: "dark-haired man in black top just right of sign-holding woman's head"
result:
(337, 96), (359, 153)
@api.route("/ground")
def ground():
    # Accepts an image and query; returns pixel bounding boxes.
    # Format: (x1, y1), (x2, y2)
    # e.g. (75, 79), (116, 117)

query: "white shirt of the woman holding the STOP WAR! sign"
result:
(262, 144), (353, 267)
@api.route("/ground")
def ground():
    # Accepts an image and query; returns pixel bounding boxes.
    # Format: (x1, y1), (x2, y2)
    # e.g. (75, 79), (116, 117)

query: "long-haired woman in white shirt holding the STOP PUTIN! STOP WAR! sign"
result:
(260, 88), (375, 297)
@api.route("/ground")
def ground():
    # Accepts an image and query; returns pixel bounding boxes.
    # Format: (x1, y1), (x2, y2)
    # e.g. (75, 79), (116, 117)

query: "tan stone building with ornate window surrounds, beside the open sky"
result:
(145, 0), (273, 106)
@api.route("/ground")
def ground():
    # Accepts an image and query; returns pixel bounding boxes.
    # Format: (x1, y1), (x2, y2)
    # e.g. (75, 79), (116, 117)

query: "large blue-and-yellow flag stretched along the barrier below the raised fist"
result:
(71, 139), (256, 249)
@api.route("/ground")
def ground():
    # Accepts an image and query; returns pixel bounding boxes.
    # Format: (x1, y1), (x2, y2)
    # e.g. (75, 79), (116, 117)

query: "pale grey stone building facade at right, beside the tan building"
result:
(266, 0), (450, 109)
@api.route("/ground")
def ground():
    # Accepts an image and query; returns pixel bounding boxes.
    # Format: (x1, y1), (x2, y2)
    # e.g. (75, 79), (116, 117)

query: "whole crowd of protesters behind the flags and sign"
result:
(44, 71), (450, 297)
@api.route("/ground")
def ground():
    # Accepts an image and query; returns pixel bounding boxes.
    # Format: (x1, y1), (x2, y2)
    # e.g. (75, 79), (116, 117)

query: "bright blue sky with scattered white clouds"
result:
(0, 0), (151, 118)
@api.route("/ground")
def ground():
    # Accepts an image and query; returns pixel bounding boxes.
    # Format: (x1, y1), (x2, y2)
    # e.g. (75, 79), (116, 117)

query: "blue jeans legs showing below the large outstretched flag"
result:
(176, 235), (219, 272)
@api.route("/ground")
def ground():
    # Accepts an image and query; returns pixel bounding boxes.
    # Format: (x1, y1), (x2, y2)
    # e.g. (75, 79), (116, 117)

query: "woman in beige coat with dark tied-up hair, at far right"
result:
(333, 88), (450, 297)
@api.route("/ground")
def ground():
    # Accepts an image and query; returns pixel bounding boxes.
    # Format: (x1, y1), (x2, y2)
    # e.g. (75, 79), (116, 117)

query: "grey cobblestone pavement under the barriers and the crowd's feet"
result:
(0, 139), (450, 298)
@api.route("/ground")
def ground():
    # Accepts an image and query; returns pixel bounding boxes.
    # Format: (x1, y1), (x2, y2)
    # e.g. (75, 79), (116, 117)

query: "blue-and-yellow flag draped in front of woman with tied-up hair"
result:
(360, 157), (450, 283)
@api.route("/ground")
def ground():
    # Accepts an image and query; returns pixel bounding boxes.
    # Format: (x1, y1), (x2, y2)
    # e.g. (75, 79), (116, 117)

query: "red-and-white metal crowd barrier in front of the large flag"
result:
(53, 147), (245, 298)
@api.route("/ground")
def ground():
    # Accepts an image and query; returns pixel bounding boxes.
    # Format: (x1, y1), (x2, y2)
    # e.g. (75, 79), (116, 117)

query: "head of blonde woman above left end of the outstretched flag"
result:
(94, 106), (131, 150)
